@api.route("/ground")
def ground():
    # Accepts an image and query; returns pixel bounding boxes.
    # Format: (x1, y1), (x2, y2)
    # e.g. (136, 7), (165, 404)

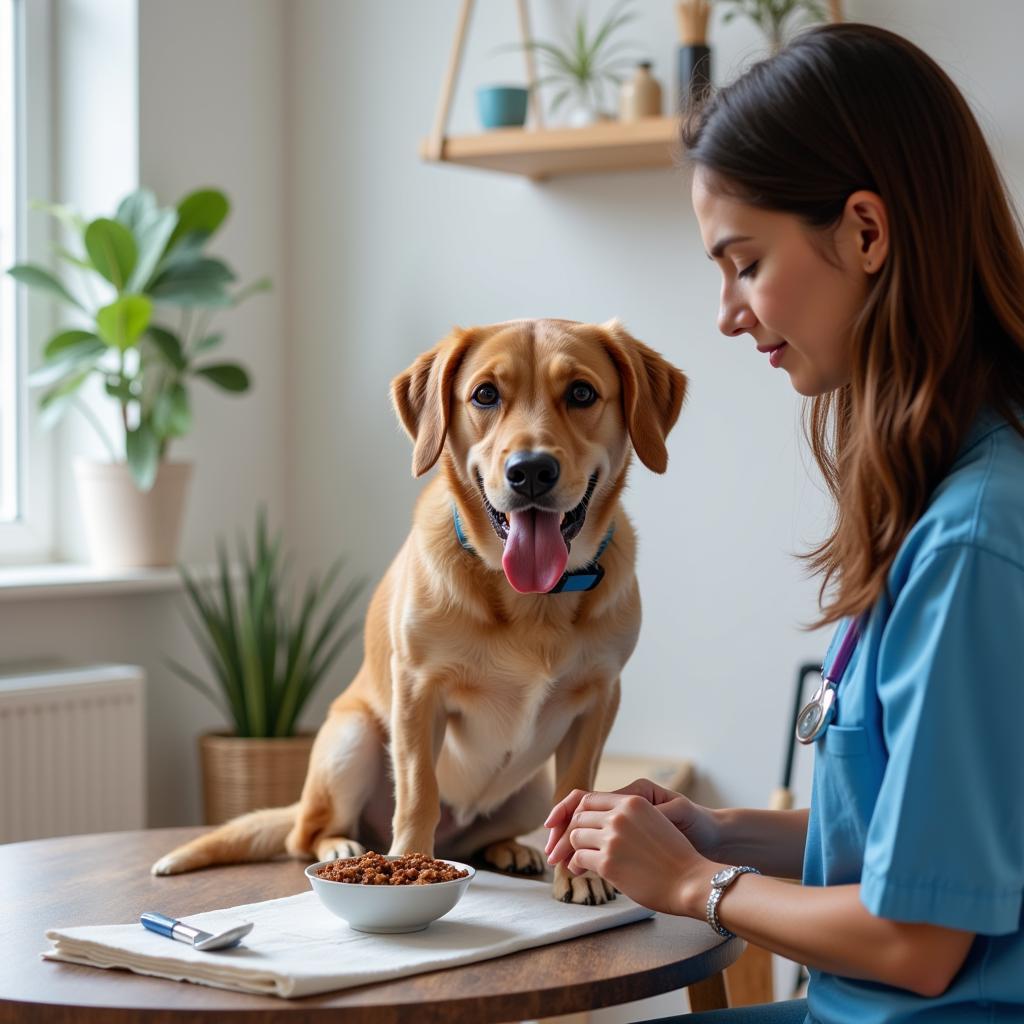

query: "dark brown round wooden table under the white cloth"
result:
(0, 828), (743, 1024)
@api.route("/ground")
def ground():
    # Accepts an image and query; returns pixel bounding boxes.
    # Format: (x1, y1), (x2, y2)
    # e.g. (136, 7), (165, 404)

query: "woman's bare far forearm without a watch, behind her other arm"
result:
(707, 807), (808, 879)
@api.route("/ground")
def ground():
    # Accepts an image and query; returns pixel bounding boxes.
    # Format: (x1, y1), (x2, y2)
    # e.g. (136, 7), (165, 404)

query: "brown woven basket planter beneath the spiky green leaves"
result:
(199, 732), (315, 825)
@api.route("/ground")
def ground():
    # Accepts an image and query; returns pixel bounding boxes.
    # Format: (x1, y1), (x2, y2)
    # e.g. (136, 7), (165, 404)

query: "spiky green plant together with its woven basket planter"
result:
(167, 509), (365, 824)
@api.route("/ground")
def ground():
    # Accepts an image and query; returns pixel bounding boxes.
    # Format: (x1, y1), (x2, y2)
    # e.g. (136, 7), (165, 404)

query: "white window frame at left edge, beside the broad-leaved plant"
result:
(0, 0), (55, 565)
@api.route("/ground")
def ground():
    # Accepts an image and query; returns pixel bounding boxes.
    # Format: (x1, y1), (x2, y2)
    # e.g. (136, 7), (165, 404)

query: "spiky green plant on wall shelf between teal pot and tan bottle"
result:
(521, 0), (637, 117)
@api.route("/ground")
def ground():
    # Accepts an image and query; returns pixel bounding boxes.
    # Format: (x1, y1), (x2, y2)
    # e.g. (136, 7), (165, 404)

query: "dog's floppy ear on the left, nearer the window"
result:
(391, 328), (472, 476)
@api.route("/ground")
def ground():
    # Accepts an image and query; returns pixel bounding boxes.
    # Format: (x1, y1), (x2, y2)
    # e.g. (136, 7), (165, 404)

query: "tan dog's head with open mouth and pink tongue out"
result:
(391, 319), (686, 593)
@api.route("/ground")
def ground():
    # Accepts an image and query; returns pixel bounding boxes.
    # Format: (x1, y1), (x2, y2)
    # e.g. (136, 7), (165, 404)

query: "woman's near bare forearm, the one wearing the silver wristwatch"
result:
(681, 865), (974, 996)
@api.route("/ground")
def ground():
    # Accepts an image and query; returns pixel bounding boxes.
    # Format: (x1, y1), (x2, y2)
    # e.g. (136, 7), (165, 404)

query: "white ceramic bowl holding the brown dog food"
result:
(306, 858), (476, 933)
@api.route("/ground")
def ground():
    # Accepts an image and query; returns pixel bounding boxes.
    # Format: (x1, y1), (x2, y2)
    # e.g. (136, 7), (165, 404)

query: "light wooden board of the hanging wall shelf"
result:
(420, 118), (679, 181)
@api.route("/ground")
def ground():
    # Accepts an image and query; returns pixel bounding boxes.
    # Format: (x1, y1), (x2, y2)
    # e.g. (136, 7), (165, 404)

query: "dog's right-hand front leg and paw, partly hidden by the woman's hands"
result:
(552, 679), (620, 904)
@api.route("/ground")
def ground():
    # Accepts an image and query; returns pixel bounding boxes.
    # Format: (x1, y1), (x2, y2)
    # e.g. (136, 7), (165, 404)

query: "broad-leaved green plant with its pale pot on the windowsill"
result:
(8, 188), (269, 567)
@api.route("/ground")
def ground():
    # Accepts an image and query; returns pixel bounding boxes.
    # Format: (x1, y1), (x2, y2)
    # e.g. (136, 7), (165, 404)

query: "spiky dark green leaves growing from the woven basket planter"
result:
(166, 508), (365, 736)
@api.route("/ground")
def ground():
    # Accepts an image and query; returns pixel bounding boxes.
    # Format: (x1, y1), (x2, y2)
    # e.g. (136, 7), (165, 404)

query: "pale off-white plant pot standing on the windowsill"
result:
(75, 458), (193, 569)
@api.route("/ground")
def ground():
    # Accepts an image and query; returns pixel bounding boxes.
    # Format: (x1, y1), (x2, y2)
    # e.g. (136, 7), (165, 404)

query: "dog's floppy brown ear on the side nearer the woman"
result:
(601, 319), (686, 473)
